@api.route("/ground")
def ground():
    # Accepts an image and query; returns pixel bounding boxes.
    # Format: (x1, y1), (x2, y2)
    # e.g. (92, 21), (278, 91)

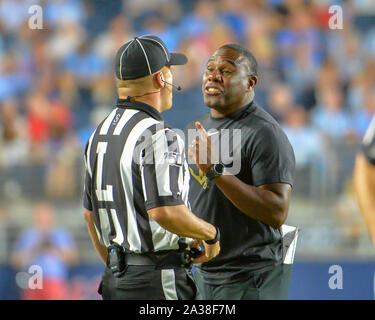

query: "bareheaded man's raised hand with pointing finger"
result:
(188, 121), (218, 174)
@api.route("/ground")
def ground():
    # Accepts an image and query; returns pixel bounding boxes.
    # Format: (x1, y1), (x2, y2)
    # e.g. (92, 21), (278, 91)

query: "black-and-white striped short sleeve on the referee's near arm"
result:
(140, 129), (185, 210)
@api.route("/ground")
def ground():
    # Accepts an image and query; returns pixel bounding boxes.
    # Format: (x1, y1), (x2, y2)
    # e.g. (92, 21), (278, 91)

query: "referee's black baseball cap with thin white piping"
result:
(115, 35), (187, 80)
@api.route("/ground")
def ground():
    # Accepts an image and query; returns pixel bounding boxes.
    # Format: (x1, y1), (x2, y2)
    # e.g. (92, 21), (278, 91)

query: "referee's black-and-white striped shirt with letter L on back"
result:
(84, 99), (190, 253)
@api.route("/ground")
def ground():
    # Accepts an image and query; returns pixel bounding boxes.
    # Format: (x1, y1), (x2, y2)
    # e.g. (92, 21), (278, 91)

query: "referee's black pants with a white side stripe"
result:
(98, 265), (200, 300)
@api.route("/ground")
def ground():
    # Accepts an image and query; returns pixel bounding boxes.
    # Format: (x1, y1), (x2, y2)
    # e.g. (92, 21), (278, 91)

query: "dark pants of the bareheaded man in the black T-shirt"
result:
(194, 264), (292, 300)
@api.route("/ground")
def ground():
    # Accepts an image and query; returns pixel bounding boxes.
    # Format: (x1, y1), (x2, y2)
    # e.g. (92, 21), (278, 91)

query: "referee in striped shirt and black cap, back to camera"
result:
(84, 36), (220, 300)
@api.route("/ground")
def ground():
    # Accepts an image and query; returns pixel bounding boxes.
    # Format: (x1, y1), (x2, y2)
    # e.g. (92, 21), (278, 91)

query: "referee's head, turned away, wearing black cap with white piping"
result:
(115, 36), (187, 112)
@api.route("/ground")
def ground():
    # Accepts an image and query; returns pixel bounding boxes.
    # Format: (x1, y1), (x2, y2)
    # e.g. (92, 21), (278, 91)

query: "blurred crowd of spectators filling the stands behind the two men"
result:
(0, 0), (375, 198)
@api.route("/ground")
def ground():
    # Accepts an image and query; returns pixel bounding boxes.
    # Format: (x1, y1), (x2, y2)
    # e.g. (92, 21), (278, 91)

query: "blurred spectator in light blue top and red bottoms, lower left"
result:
(12, 203), (77, 300)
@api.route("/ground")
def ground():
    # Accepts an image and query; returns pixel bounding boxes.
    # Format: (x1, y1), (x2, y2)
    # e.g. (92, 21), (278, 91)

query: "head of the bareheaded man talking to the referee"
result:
(202, 44), (258, 115)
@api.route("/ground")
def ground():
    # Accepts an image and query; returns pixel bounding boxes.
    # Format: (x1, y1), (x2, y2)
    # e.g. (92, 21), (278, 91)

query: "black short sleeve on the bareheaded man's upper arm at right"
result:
(248, 124), (295, 187)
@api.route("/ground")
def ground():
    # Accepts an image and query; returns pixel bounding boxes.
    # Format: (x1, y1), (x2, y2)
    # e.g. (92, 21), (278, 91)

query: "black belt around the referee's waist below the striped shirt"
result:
(125, 251), (184, 267)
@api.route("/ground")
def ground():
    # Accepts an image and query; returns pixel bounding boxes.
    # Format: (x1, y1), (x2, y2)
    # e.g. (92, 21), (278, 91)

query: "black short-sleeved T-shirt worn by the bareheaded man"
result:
(185, 103), (295, 285)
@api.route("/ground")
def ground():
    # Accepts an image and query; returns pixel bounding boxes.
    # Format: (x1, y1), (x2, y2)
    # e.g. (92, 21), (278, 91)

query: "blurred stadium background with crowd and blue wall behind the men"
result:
(0, 0), (375, 299)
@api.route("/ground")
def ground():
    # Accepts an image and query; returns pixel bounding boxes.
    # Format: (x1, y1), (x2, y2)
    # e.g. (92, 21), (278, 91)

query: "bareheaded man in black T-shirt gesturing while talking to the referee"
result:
(185, 44), (295, 299)
